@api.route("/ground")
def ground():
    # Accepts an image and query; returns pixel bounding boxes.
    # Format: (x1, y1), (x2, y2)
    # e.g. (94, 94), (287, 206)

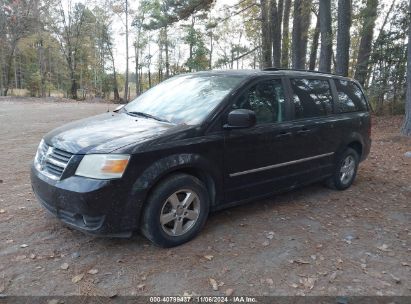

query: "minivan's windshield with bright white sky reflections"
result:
(124, 74), (244, 125)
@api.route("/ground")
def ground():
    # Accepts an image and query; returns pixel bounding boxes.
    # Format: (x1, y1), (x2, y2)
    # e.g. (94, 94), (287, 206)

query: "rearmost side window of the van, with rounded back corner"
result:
(335, 79), (367, 113)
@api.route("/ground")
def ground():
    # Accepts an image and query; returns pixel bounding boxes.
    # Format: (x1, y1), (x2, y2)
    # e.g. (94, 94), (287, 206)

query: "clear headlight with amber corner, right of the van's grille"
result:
(76, 154), (130, 179)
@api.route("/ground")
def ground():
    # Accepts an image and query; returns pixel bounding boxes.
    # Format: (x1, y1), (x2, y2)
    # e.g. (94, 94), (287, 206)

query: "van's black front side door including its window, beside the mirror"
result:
(224, 78), (298, 203)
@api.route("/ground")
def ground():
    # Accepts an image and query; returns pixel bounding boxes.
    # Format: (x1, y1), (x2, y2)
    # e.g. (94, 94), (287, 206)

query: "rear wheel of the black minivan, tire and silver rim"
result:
(326, 148), (360, 190)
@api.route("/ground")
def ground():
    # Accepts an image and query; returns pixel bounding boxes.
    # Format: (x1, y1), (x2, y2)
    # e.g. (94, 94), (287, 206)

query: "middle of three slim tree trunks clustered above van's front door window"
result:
(270, 0), (283, 67)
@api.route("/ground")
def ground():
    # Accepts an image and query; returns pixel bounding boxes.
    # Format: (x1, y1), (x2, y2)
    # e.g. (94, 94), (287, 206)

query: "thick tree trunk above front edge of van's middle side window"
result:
(291, 0), (311, 69)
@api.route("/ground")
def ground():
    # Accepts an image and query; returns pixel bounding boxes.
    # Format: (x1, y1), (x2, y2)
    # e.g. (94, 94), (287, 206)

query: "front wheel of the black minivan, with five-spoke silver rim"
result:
(141, 173), (210, 247)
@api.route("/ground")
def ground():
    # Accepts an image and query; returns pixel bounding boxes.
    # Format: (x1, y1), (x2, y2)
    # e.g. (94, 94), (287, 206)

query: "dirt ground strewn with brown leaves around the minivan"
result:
(0, 98), (411, 295)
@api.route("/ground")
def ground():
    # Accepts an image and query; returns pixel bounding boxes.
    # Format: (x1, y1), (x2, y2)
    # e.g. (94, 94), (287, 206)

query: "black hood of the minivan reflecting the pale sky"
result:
(44, 112), (188, 154)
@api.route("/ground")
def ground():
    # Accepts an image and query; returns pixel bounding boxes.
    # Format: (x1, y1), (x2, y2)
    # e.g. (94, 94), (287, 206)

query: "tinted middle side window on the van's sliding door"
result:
(291, 79), (332, 119)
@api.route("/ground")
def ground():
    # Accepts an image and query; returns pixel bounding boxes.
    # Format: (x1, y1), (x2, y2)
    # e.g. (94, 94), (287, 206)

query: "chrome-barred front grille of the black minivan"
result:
(35, 141), (73, 180)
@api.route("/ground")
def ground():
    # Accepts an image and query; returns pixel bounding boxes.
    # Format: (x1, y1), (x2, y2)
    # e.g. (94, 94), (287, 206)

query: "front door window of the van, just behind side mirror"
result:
(233, 79), (285, 124)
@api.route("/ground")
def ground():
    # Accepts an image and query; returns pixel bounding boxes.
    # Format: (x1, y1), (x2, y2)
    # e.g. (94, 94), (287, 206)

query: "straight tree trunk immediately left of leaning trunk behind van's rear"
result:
(335, 0), (352, 76)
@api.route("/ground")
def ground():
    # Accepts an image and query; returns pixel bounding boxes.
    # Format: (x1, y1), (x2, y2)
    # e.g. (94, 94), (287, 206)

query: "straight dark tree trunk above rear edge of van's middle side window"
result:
(318, 0), (332, 73)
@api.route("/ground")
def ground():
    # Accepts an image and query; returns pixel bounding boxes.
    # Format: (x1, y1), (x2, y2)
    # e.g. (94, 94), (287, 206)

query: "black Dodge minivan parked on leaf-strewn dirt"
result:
(31, 68), (371, 247)
